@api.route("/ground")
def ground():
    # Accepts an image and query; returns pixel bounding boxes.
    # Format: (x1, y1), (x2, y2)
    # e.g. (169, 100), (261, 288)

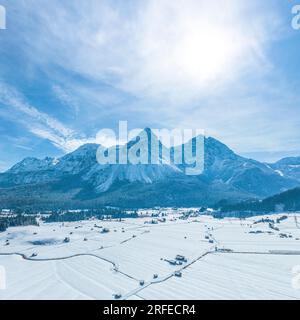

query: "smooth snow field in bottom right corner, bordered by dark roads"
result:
(139, 254), (300, 300)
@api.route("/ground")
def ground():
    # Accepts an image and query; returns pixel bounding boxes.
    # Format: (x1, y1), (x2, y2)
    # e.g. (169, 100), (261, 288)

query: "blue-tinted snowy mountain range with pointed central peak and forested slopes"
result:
(0, 129), (300, 209)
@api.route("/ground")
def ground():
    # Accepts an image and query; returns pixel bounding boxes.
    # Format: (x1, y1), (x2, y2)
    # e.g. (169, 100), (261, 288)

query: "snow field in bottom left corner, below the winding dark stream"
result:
(0, 256), (136, 299)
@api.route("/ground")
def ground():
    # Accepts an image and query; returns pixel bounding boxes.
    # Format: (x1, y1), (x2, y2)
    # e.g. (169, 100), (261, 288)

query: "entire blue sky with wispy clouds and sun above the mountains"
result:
(0, 0), (300, 171)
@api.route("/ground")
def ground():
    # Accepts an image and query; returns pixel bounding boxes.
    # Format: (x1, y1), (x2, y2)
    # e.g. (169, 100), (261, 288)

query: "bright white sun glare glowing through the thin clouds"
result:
(138, 3), (244, 95)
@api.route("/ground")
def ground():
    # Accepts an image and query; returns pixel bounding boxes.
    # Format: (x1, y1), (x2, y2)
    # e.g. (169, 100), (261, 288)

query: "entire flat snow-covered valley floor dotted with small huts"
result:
(0, 214), (300, 299)
